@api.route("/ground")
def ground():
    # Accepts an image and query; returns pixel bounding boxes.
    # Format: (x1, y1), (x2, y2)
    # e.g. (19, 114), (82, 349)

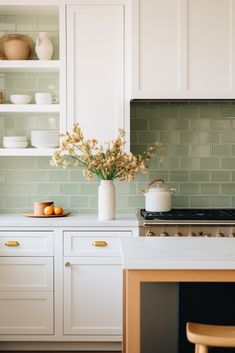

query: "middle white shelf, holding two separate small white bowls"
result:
(0, 104), (60, 113)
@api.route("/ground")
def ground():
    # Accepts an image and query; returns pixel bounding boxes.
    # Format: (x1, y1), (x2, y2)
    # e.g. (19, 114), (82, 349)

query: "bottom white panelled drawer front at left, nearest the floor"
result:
(0, 292), (53, 334)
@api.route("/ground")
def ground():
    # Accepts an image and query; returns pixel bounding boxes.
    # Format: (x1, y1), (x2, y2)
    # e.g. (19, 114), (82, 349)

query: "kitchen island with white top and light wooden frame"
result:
(120, 238), (235, 353)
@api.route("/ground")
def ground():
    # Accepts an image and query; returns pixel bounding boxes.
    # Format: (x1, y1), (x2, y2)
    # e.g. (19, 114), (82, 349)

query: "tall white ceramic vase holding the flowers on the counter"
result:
(98, 180), (116, 220)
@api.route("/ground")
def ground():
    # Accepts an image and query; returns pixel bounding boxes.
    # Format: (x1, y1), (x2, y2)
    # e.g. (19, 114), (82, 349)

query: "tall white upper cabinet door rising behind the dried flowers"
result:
(67, 1), (129, 141)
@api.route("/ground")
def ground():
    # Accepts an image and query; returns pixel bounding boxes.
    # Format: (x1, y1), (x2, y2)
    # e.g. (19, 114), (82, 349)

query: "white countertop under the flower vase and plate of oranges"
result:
(0, 214), (138, 227)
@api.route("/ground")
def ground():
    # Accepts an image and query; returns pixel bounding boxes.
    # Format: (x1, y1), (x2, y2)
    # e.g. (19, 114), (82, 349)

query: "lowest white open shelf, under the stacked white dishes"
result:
(0, 148), (56, 157)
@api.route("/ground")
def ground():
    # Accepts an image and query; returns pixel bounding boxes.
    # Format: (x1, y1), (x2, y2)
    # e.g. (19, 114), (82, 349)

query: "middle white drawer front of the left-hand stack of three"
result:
(0, 257), (53, 292)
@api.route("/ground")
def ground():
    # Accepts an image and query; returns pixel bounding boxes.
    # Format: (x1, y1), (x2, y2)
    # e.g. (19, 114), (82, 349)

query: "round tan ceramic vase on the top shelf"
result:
(3, 34), (31, 60)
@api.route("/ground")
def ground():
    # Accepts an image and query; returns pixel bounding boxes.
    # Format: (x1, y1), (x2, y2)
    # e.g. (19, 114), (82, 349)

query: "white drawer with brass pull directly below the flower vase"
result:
(64, 231), (132, 256)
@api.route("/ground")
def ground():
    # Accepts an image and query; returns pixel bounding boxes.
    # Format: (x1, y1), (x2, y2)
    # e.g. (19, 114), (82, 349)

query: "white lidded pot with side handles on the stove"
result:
(141, 178), (176, 212)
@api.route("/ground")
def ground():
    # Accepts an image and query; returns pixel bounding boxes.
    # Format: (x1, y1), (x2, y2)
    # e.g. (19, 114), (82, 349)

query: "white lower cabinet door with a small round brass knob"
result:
(64, 257), (122, 340)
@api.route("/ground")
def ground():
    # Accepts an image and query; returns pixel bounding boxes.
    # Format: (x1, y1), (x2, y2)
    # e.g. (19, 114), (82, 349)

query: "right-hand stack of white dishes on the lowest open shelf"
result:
(31, 130), (59, 148)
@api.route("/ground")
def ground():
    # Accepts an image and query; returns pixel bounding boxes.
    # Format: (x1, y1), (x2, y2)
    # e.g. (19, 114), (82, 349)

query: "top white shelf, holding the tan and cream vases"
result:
(0, 60), (60, 72)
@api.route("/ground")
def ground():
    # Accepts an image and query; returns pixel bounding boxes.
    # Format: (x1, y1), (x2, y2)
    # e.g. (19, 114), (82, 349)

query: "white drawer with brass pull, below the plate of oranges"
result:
(0, 231), (53, 256)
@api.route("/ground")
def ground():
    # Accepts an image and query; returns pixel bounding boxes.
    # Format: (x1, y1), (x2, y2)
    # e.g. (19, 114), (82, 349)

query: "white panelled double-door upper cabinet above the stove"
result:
(132, 0), (235, 98)
